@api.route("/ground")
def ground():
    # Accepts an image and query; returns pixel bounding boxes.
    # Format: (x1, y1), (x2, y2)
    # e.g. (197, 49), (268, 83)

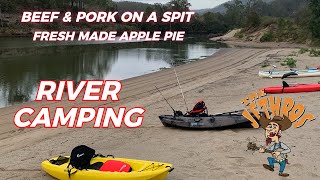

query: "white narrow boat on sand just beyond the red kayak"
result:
(259, 69), (320, 78)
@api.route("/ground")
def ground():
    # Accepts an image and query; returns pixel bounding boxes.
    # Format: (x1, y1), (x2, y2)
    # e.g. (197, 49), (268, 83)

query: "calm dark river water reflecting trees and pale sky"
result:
(0, 37), (225, 107)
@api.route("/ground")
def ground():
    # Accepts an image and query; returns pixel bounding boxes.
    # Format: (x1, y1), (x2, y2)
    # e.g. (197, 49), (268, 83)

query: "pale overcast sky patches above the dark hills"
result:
(115, 0), (229, 10)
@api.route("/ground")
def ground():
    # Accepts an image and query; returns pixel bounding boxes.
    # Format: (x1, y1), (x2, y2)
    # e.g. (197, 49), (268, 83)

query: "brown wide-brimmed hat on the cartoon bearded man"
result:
(259, 114), (292, 131)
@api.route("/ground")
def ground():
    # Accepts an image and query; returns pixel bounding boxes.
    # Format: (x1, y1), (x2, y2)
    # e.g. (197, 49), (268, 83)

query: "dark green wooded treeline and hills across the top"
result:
(0, 0), (320, 41)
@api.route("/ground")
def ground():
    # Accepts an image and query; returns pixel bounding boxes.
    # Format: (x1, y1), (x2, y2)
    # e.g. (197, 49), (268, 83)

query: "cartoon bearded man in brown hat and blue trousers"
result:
(259, 115), (292, 177)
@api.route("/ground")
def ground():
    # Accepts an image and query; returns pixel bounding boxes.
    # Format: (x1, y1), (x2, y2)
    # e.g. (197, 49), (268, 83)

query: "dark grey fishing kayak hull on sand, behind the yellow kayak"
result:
(159, 110), (254, 129)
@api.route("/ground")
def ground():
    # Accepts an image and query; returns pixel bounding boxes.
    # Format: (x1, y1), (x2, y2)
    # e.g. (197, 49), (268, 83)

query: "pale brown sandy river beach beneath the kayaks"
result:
(0, 46), (320, 180)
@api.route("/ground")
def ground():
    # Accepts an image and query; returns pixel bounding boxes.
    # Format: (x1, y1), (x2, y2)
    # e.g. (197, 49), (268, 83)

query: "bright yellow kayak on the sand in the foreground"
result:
(41, 156), (173, 180)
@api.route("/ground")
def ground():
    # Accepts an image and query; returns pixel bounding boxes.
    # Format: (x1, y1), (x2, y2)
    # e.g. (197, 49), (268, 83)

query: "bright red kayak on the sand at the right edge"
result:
(264, 84), (320, 94)
